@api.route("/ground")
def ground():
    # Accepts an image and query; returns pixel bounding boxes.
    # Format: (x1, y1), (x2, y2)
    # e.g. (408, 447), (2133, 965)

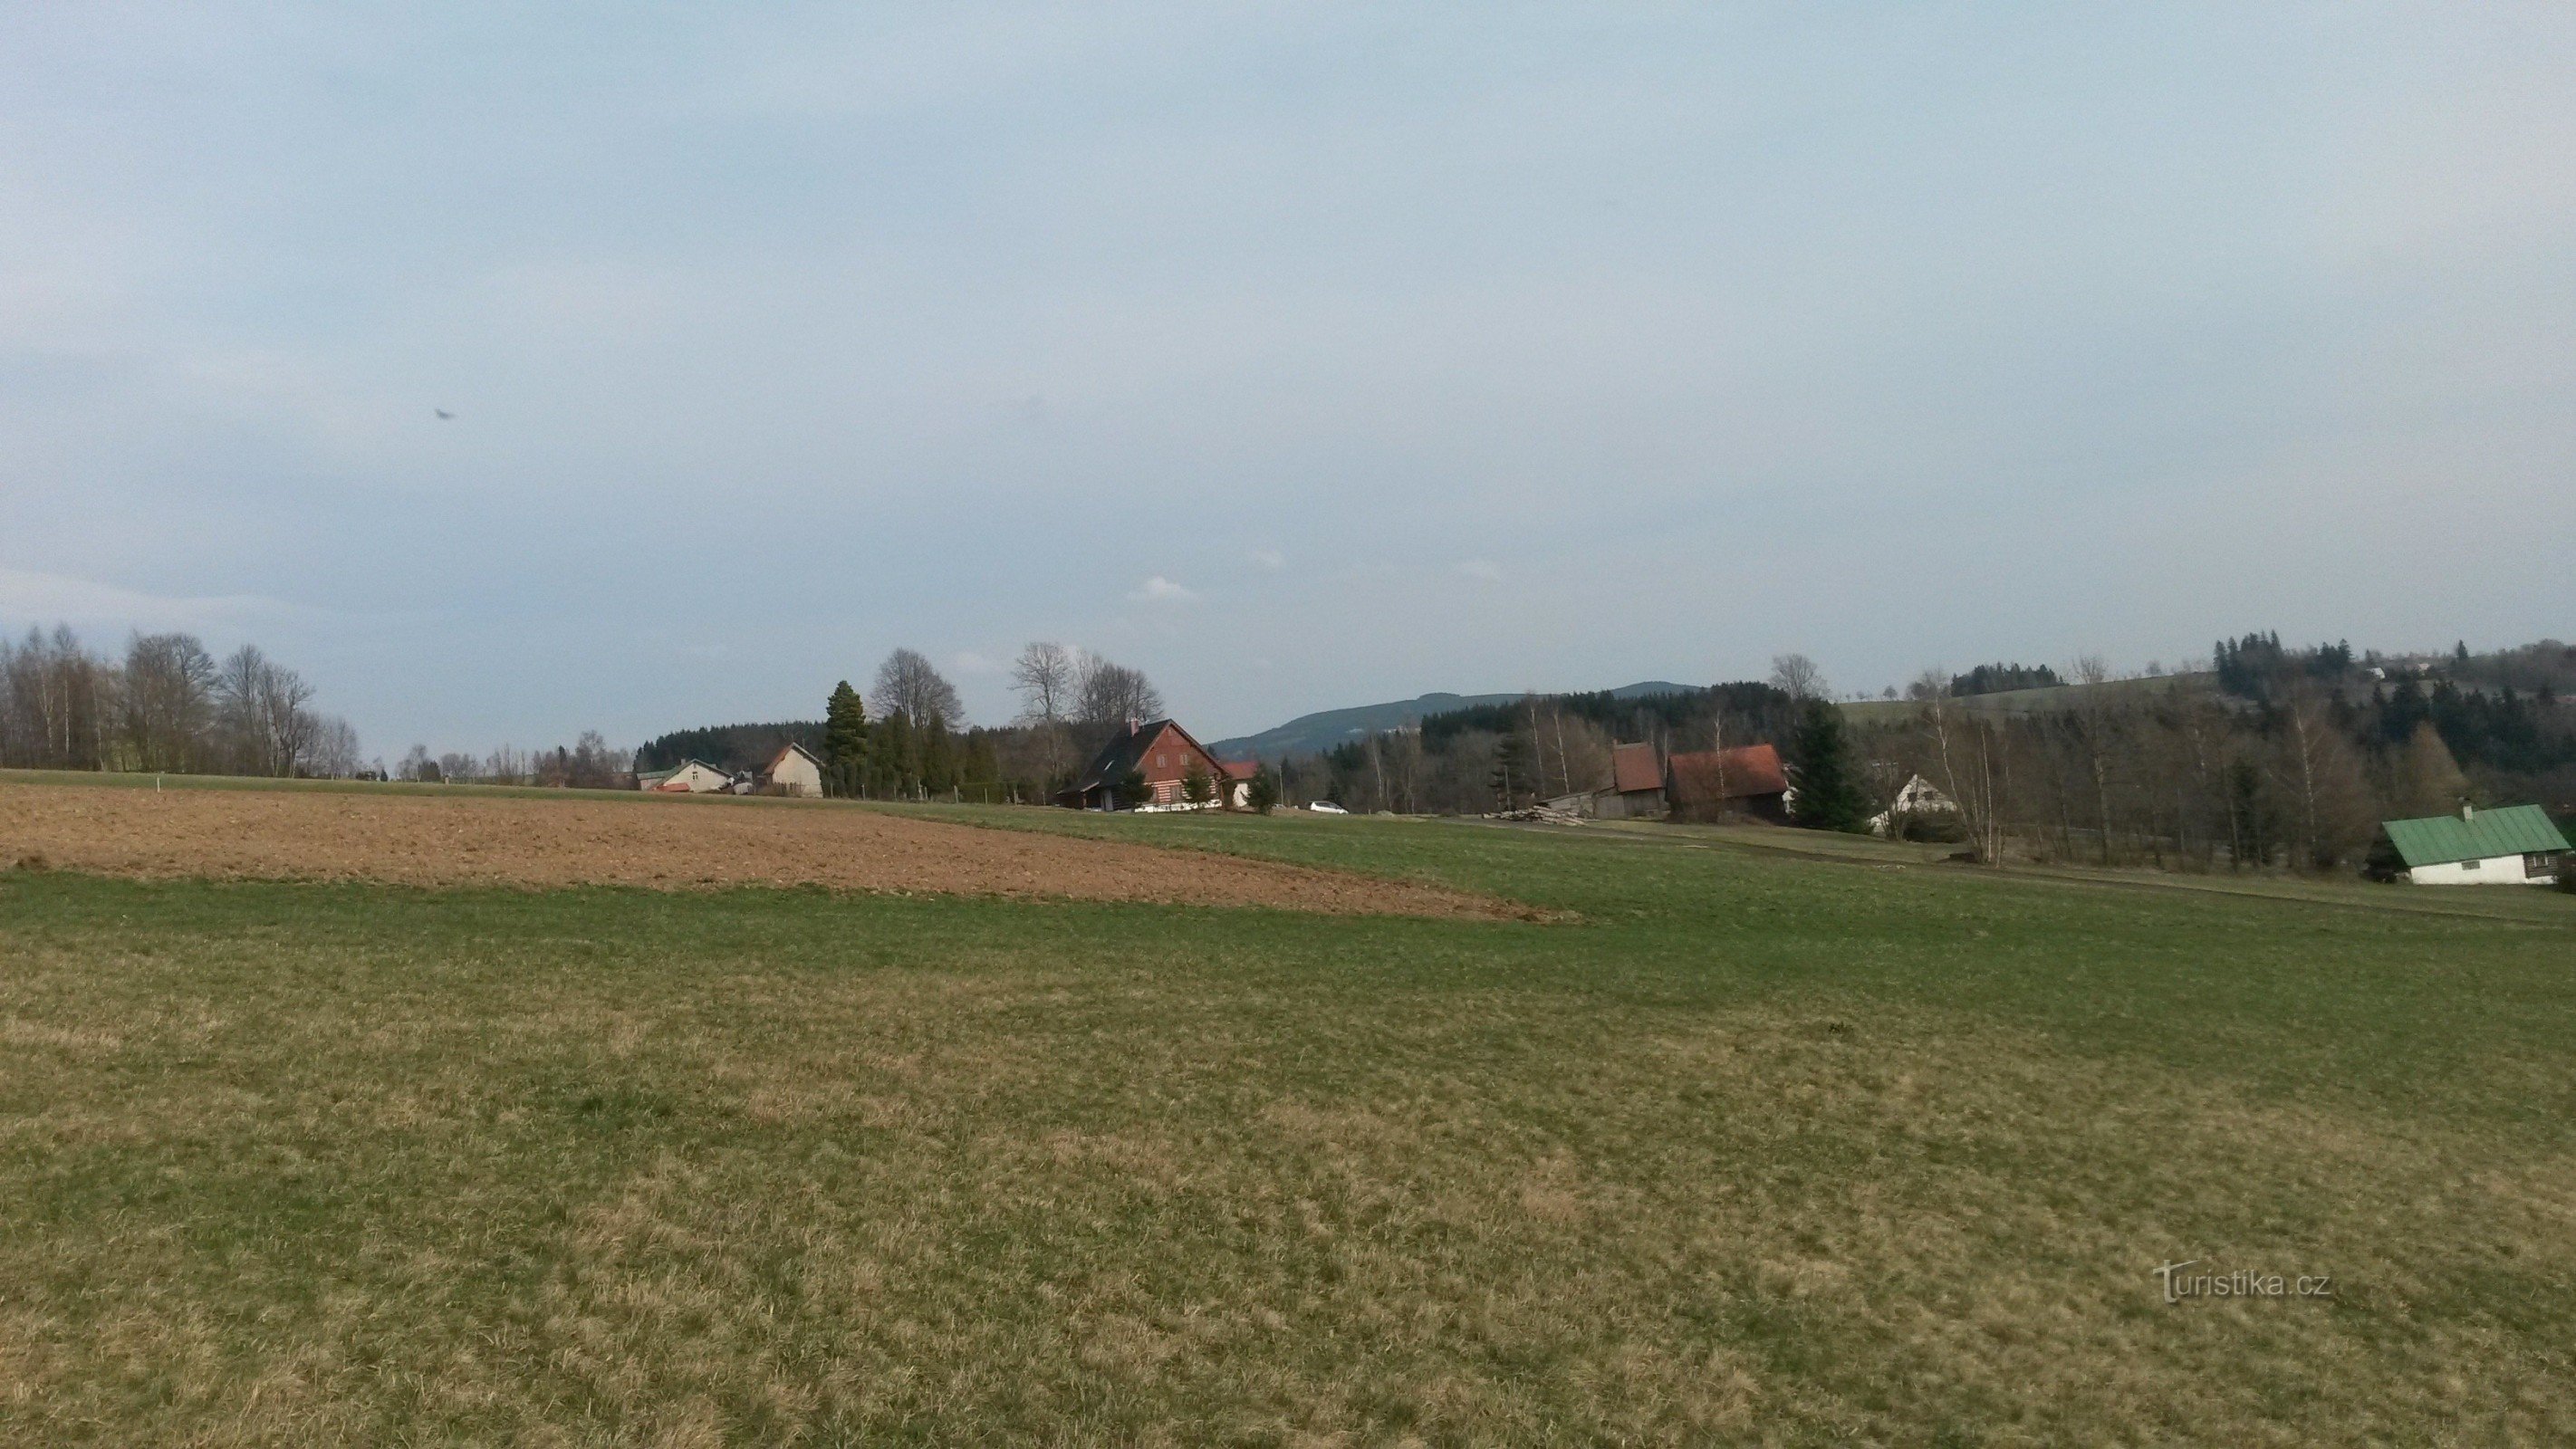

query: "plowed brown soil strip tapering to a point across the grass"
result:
(0, 785), (1533, 916)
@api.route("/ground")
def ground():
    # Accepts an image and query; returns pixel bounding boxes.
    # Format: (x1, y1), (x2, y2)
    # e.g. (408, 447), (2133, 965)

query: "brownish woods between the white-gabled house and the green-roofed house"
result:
(1865, 633), (2576, 870)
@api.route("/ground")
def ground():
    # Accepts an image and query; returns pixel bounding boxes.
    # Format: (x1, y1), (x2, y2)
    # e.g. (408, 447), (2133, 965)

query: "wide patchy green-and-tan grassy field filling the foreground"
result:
(0, 785), (2576, 1444)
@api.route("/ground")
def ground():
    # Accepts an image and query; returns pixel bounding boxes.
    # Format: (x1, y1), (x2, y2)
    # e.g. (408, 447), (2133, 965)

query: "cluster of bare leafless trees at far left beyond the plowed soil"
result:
(0, 626), (366, 777)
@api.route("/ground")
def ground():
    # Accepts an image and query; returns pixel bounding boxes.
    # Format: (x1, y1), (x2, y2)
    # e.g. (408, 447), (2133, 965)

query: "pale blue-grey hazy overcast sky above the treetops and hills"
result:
(0, 0), (2576, 757)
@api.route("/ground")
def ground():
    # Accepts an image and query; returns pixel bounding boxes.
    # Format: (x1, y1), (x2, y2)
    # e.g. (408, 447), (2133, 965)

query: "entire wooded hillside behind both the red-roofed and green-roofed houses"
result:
(1283, 633), (2576, 870)
